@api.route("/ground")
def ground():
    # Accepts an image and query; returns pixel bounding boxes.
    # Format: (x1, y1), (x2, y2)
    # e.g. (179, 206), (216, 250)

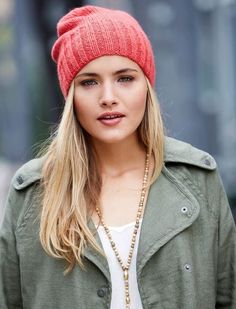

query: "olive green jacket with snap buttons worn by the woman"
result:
(0, 138), (236, 309)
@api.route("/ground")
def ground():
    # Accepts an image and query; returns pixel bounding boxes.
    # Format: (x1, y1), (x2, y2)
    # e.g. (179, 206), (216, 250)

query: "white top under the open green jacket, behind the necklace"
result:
(98, 220), (143, 309)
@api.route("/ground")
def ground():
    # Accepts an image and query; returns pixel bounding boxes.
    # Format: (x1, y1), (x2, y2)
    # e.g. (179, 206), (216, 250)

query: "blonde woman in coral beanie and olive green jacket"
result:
(0, 6), (236, 309)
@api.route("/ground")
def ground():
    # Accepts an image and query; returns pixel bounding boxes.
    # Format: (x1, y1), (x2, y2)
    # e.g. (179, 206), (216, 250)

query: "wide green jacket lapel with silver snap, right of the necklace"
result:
(137, 167), (200, 275)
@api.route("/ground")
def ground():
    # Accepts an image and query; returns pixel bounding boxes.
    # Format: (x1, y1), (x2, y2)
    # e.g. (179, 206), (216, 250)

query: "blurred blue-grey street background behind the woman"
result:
(0, 0), (236, 219)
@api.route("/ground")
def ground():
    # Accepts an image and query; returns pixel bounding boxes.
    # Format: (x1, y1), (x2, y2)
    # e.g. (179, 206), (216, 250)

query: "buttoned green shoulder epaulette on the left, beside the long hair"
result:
(12, 157), (45, 190)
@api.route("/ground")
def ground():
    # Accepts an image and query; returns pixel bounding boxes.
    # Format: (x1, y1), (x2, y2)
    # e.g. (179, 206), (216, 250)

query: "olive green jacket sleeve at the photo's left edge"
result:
(0, 182), (23, 309)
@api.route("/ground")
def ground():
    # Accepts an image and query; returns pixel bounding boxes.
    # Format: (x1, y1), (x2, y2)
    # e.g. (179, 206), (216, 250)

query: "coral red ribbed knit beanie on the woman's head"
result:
(52, 6), (155, 98)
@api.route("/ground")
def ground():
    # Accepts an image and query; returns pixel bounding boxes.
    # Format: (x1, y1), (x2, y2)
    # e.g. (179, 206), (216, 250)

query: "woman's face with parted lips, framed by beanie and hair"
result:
(74, 56), (147, 143)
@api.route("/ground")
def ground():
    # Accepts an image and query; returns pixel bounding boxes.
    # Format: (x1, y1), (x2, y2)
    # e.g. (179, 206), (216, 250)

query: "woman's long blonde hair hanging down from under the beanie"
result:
(40, 79), (164, 272)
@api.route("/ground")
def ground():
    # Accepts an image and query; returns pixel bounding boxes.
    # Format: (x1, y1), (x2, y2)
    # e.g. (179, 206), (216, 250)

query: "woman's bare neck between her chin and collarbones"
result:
(93, 139), (146, 177)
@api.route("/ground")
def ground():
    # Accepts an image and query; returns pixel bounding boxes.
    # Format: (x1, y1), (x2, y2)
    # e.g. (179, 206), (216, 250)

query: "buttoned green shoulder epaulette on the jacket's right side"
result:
(164, 137), (217, 170)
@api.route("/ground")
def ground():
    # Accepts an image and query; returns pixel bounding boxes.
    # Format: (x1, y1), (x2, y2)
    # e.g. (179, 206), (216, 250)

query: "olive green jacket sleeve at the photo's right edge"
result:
(215, 173), (236, 309)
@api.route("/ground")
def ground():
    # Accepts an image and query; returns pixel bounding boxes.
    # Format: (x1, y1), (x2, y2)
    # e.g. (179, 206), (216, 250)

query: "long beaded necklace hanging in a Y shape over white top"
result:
(96, 154), (149, 309)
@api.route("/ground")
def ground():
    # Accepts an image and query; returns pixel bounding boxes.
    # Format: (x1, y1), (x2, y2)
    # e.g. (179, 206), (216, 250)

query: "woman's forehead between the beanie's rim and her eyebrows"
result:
(78, 55), (142, 74)
